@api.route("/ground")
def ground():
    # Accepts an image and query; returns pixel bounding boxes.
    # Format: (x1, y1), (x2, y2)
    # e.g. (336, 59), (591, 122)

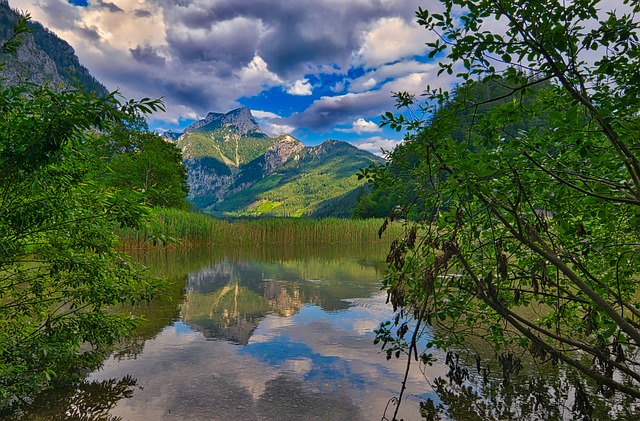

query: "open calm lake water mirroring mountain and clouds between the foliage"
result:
(37, 247), (444, 421)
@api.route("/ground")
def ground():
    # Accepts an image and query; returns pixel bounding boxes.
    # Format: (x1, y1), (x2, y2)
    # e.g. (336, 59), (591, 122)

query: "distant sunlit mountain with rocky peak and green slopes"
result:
(164, 107), (381, 217)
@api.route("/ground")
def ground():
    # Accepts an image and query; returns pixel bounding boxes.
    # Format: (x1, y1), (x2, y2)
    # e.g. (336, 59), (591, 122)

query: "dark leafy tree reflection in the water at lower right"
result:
(420, 353), (640, 421)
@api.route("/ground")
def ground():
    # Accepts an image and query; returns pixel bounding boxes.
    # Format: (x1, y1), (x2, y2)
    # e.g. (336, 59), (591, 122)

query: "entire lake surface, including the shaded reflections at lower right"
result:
(21, 246), (638, 421)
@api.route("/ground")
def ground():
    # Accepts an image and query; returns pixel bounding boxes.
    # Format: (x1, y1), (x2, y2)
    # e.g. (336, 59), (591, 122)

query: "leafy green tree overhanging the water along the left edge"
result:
(0, 16), (162, 416)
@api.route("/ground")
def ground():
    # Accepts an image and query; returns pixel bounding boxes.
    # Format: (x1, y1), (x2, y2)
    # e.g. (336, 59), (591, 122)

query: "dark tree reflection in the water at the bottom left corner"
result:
(14, 375), (141, 421)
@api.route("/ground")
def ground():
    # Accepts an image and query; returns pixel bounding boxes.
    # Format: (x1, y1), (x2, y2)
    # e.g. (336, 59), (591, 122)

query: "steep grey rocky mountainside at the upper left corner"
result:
(0, 0), (107, 96)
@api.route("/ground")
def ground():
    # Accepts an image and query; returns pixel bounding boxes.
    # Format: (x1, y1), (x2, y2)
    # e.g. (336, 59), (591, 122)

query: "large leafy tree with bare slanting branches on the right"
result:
(363, 0), (640, 416)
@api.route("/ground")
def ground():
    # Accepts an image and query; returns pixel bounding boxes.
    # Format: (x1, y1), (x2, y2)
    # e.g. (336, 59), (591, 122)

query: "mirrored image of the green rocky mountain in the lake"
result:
(180, 254), (379, 345)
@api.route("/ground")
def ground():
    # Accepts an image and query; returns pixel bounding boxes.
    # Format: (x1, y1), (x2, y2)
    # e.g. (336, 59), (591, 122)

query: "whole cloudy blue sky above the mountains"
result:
(16, 0), (451, 152)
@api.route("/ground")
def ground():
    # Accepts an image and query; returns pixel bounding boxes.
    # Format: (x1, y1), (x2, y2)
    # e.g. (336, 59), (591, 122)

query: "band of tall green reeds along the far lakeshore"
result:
(117, 209), (401, 248)
